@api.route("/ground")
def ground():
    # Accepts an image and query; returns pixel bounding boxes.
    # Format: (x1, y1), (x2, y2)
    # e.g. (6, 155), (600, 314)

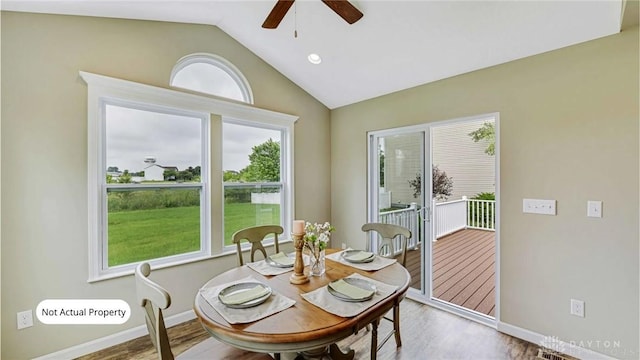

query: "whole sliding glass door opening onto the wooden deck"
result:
(368, 114), (499, 326)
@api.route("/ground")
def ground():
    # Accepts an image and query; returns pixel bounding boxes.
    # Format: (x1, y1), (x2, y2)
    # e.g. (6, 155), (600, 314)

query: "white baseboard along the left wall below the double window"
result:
(34, 310), (196, 360)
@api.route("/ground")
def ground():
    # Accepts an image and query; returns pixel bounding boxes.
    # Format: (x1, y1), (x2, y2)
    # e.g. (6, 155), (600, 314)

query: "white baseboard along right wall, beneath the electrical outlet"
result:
(496, 322), (615, 360)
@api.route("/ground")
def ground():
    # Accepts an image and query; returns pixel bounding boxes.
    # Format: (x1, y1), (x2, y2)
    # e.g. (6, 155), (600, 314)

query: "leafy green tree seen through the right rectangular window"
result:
(241, 139), (280, 182)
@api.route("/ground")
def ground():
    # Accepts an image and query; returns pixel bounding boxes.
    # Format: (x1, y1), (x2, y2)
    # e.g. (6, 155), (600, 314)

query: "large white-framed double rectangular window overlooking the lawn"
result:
(80, 72), (297, 281)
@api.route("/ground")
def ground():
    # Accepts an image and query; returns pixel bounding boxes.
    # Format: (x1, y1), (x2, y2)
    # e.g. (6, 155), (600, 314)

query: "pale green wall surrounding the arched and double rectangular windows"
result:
(0, 12), (330, 359)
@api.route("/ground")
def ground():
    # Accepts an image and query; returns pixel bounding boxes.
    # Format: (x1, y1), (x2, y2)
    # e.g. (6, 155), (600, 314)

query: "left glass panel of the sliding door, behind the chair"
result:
(369, 126), (431, 294)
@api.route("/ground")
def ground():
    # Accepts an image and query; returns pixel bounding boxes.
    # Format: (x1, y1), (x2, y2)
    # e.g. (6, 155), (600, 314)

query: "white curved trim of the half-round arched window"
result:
(169, 53), (253, 104)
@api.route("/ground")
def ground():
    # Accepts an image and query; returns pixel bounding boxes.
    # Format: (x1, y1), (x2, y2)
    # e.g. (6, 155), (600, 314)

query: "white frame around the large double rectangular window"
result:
(79, 71), (298, 282)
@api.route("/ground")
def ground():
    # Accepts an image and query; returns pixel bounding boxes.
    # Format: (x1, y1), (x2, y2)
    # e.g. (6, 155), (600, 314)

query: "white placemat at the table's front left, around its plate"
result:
(200, 276), (296, 324)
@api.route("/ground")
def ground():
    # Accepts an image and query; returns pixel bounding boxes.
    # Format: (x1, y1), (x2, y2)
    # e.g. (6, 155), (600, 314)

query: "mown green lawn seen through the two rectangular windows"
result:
(109, 203), (280, 266)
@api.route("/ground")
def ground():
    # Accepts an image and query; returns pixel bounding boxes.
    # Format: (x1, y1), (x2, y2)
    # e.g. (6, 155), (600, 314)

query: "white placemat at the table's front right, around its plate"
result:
(300, 274), (398, 317)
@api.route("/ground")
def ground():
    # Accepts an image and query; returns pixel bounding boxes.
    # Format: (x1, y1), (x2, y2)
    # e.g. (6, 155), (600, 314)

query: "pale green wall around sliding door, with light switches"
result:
(331, 26), (640, 359)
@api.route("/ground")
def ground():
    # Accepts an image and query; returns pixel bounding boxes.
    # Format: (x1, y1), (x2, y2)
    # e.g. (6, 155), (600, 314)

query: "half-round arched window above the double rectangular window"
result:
(170, 54), (253, 104)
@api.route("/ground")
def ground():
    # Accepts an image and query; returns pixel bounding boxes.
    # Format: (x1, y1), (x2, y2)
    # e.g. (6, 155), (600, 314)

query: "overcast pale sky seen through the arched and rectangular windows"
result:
(106, 63), (280, 172)
